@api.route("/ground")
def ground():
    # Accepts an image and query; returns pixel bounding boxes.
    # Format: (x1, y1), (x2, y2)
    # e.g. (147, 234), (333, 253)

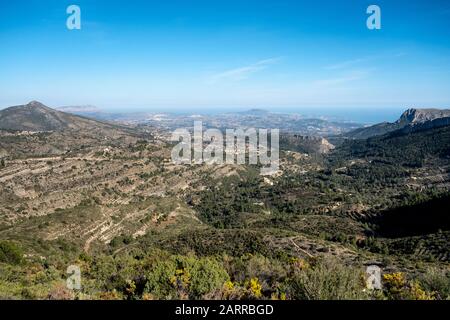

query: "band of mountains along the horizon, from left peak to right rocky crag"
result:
(0, 101), (450, 139)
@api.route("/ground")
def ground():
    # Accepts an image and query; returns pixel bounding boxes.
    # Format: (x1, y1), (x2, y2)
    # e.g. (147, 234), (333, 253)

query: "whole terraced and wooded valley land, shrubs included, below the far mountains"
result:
(0, 108), (450, 300)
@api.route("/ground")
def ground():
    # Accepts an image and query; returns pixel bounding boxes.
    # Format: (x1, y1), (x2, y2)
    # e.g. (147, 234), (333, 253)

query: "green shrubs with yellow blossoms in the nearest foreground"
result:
(0, 242), (450, 300)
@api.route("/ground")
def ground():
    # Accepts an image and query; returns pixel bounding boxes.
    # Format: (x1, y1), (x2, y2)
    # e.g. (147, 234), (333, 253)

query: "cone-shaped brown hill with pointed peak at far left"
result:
(0, 101), (151, 159)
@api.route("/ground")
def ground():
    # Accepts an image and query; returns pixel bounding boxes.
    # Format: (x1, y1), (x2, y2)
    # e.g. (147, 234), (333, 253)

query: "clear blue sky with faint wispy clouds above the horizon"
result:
(0, 0), (450, 117)
